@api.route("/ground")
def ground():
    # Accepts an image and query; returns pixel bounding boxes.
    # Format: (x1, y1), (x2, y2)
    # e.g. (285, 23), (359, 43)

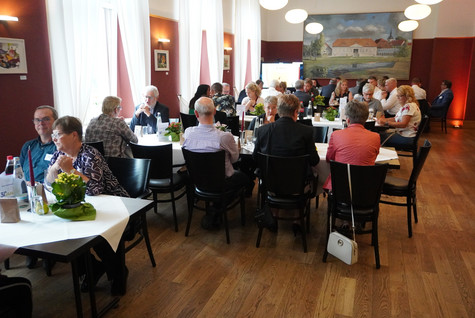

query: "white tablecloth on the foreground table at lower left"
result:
(0, 195), (129, 262)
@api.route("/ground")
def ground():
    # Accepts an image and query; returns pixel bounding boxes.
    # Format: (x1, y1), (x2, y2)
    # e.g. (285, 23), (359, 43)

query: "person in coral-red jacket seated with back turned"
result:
(323, 102), (380, 190)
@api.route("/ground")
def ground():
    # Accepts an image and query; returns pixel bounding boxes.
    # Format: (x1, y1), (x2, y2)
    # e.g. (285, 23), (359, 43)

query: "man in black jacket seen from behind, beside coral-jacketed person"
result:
(253, 94), (320, 166)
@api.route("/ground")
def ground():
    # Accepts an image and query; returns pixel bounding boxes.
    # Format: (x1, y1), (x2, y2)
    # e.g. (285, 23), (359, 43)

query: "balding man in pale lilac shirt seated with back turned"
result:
(183, 97), (249, 230)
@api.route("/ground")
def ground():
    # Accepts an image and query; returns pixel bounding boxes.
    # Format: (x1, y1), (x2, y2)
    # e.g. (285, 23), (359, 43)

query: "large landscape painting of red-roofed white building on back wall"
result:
(302, 12), (412, 80)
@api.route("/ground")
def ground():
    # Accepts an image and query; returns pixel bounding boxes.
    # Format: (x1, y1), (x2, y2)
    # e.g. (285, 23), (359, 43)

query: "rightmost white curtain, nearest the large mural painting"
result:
(234, 0), (261, 91)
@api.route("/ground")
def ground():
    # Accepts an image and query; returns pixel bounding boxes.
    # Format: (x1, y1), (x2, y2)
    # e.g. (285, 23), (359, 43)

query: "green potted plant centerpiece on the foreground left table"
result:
(49, 172), (96, 221)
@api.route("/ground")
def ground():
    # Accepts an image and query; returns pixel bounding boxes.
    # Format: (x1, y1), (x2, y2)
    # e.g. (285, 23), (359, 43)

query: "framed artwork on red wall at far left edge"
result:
(0, 38), (27, 74)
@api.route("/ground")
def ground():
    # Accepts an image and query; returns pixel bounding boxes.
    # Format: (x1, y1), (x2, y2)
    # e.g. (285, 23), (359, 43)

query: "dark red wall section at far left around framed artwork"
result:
(0, 0), (54, 171)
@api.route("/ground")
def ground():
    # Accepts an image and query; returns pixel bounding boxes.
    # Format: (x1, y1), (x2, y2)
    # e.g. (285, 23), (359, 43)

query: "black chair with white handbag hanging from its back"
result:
(323, 161), (388, 268)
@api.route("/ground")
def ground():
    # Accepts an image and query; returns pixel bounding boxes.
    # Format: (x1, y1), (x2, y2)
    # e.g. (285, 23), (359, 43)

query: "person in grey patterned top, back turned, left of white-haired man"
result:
(86, 96), (138, 158)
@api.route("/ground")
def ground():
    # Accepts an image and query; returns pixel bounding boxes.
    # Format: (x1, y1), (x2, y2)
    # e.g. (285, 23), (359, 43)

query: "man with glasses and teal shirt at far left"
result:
(20, 105), (58, 182)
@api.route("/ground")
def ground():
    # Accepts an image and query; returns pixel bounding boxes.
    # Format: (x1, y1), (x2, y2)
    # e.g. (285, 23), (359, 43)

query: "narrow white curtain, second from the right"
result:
(202, 0), (224, 84)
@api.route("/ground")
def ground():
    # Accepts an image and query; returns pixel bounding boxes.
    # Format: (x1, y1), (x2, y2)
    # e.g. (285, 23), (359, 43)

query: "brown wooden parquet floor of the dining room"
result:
(2, 122), (475, 318)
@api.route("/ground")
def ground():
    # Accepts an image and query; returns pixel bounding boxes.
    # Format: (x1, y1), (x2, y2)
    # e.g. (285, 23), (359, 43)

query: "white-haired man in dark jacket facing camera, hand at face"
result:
(130, 85), (169, 133)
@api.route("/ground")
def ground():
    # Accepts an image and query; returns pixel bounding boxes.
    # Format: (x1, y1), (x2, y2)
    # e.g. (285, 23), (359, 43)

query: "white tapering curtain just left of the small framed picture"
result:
(117, 0), (152, 105)
